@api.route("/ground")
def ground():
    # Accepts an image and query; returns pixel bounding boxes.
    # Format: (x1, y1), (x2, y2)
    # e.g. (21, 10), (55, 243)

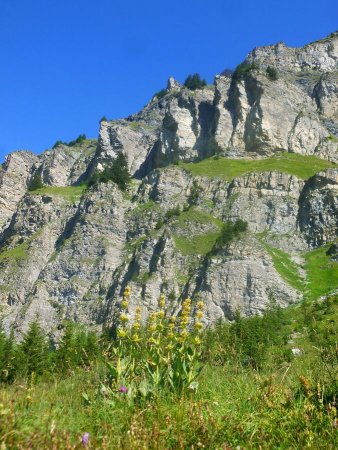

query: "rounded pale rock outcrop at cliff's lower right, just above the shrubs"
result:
(196, 240), (297, 323)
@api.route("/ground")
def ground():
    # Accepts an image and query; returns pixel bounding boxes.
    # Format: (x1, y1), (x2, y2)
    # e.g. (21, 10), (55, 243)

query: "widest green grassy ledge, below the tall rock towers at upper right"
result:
(179, 152), (336, 181)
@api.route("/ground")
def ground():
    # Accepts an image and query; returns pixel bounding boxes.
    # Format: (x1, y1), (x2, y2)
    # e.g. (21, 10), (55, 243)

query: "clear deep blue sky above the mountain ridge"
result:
(0, 0), (338, 161)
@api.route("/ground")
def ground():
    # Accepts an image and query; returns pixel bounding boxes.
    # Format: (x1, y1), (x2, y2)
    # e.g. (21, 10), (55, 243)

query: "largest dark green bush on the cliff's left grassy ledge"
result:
(88, 153), (131, 191)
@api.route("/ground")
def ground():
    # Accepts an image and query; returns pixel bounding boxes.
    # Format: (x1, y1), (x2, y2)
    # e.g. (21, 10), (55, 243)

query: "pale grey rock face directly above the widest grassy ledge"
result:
(215, 73), (337, 161)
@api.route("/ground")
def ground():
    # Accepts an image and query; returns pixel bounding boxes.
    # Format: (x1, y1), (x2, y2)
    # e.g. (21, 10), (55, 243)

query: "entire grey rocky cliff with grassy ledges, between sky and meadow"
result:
(0, 33), (338, 335)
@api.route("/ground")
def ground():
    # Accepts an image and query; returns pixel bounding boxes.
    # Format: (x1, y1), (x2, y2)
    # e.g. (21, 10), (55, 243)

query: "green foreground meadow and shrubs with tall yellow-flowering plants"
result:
(0, 291), (338, 449)
